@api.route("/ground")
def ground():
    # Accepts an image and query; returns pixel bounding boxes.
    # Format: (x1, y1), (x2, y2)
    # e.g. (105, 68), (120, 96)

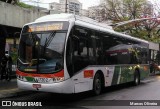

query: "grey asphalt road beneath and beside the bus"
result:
(0, 76), (160, 109)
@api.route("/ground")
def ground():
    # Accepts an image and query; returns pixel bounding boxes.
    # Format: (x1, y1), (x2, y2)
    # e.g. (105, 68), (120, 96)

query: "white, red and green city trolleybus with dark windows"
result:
(16, 13), (149, 95)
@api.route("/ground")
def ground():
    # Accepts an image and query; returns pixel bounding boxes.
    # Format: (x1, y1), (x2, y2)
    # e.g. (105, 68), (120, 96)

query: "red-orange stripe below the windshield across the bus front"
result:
(16, 70), (64, 78)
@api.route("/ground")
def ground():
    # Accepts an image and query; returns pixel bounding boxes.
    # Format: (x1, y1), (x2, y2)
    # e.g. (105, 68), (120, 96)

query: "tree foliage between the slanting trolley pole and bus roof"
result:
(114, 18), (160, 43)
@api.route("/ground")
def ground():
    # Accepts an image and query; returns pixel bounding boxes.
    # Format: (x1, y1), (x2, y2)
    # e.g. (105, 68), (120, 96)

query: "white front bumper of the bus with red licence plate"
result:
(17, 79), (74, 94)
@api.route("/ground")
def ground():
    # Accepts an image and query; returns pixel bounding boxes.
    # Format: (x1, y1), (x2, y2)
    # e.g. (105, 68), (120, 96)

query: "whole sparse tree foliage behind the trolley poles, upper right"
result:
(101, 0), (160, 42)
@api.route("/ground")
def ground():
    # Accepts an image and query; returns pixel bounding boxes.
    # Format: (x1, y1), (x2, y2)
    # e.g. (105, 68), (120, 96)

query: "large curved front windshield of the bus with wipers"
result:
(17, 21), (69, 74)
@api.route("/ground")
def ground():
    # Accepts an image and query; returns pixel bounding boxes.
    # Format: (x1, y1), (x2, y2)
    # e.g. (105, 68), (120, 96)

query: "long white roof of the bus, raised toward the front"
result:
(32, 13), (148, 43)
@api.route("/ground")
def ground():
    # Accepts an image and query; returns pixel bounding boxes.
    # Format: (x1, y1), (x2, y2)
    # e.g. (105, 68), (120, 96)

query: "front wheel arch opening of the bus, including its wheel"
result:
(92, 70), (104, 95)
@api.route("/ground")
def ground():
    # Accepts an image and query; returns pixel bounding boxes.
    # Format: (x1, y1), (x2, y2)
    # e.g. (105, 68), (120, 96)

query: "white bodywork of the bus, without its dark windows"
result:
(17, 14), (149, 94)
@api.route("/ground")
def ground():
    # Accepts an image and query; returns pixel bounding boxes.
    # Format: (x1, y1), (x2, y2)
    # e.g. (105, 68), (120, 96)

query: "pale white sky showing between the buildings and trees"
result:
(20, 0), (100, 9)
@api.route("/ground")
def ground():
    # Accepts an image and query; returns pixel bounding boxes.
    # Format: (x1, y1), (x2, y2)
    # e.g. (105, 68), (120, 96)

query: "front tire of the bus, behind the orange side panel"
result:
(93, 73), (102, 95)
